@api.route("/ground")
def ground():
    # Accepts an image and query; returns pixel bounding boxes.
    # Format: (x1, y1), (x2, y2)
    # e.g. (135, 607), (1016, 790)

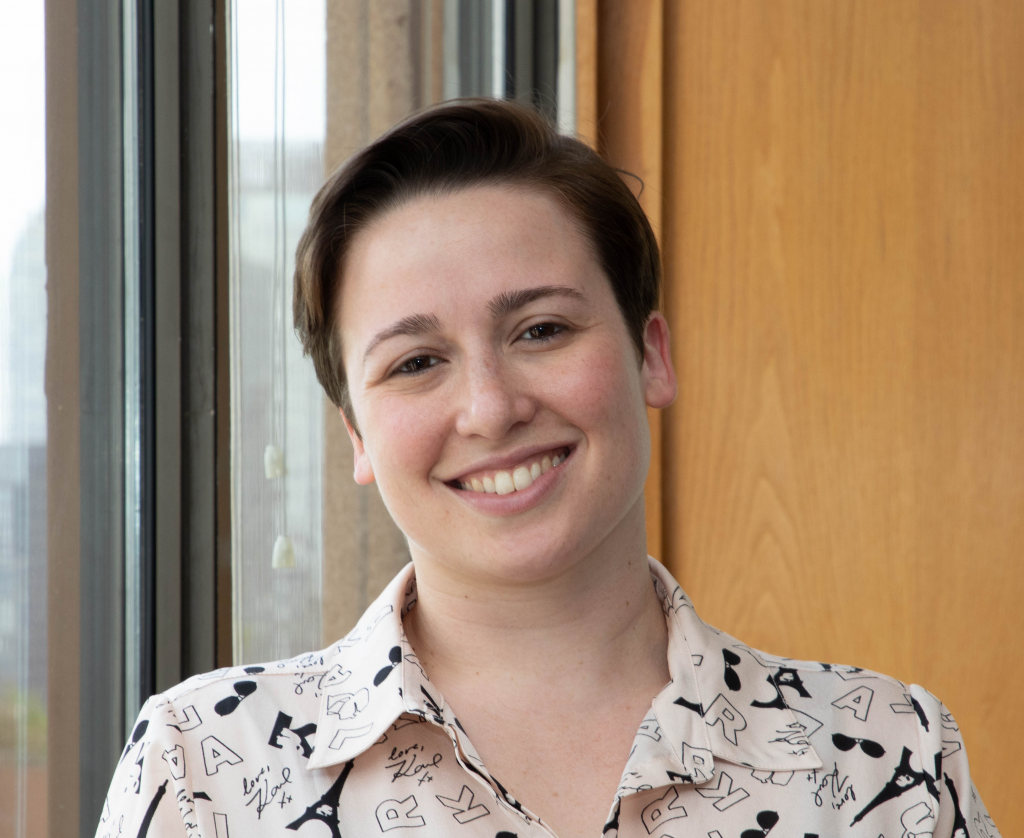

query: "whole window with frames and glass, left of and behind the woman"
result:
(36, 0), (572, 838)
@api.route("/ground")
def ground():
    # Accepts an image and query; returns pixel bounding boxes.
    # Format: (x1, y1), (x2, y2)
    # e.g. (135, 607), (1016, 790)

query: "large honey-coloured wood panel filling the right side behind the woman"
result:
(664, 0), (1024, 823)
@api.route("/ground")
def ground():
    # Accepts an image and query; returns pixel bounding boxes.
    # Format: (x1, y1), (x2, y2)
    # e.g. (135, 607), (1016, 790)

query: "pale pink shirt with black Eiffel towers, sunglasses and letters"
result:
(96, 559), (998, 838)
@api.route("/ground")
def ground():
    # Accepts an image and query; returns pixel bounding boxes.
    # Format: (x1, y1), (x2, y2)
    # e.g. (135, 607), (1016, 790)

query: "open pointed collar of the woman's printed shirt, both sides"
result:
(308, 558), (822, 796)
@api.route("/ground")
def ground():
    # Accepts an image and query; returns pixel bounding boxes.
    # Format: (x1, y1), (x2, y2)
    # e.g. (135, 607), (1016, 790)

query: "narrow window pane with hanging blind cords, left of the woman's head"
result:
(229, 0), (326, 663)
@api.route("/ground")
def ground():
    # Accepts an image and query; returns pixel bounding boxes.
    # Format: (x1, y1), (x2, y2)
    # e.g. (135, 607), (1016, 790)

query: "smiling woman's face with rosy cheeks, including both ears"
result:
(340, 186), (675, 582)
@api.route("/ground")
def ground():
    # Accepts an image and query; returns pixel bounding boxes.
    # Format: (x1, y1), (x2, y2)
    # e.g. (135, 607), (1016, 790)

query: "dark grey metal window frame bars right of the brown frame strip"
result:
(125, 0), (229, 716)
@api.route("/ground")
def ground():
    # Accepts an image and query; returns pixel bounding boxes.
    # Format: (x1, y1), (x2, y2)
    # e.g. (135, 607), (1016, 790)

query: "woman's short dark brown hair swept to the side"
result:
(293, 99), (662, 421)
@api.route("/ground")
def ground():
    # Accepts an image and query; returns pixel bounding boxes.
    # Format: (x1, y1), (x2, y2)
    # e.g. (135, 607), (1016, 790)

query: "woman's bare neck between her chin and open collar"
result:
(406, 501), (669, 697)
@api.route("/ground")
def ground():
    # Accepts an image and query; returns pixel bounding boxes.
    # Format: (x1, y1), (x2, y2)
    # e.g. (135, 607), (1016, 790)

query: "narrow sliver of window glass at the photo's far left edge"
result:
(0, 0), (46, 838)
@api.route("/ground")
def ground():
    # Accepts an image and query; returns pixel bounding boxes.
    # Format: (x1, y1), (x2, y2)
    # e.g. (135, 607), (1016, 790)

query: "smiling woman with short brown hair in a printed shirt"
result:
(97, 101), (997, 838)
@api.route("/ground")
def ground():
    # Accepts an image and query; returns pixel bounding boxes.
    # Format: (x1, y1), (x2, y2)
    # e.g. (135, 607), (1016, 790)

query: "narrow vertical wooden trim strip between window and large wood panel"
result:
(597, 0), (664, 556)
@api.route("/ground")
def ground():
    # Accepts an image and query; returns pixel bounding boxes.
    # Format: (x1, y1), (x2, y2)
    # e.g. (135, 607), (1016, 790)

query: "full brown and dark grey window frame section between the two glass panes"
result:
(45, 0), (230, 836)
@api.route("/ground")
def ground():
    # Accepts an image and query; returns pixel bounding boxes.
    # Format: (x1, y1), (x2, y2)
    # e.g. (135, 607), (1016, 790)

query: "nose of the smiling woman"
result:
(456, 355), (537, 439)
